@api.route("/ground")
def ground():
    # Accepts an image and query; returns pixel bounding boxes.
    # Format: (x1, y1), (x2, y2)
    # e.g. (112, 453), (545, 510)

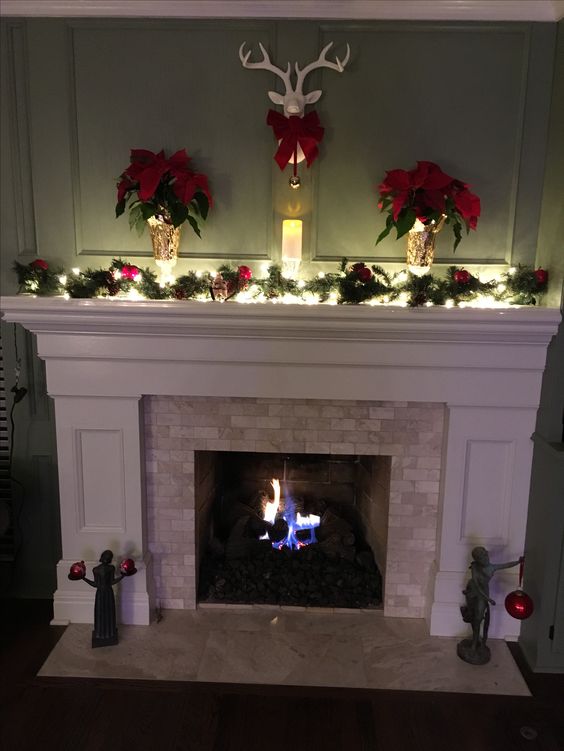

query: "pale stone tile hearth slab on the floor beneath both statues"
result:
(39, 606), (530, 696)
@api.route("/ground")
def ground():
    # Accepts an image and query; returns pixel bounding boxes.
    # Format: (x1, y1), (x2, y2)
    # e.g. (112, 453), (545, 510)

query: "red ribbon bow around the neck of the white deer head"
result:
(266, 110), (324, 169)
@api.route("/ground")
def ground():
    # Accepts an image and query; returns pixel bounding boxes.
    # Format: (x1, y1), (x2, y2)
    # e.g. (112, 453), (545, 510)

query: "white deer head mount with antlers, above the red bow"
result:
(239, 42), (351, 117)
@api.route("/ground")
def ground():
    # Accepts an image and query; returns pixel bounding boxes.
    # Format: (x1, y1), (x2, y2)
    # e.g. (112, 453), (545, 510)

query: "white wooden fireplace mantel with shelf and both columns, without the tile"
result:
(0, 296), (561, 638)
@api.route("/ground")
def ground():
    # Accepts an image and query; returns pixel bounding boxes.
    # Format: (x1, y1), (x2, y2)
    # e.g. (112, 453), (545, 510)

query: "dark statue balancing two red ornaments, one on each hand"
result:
(69, 550), (137, 647)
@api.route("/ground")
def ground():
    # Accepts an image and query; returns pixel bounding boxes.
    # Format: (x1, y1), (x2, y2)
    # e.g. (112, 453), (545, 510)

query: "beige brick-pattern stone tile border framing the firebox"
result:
(144, 396), (445, 618)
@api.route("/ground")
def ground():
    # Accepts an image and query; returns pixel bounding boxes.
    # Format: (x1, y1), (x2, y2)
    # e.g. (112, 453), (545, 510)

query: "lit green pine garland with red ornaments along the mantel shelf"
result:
(14, 258), (548, 307)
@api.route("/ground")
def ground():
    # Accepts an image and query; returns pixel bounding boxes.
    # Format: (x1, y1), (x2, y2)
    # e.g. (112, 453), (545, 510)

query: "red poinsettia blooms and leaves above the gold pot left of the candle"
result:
(116, 149), (212, 237)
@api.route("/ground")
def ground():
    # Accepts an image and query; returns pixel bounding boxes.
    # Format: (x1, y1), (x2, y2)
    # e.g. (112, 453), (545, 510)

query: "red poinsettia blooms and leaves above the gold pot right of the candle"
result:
(376, 162), (480, 250)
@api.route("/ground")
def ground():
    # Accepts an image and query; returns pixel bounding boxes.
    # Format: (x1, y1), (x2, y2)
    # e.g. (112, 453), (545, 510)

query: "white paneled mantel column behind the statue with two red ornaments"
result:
(49, 396), (152, 625)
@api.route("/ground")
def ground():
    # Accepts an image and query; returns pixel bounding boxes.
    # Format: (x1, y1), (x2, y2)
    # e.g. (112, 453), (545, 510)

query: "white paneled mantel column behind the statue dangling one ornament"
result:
(430, 404), (536, 640)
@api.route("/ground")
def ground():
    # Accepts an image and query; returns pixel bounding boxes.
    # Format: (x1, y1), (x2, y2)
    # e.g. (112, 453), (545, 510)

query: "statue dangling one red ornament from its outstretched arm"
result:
(456, 546), (532, 665)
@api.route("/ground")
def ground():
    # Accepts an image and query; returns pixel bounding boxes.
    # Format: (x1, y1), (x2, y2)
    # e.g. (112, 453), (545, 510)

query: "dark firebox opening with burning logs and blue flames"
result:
(195, 451), (391, 608)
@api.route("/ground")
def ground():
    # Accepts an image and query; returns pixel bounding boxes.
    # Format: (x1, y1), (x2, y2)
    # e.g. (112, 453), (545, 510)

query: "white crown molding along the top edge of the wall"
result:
(1, 0), (564, 22)
